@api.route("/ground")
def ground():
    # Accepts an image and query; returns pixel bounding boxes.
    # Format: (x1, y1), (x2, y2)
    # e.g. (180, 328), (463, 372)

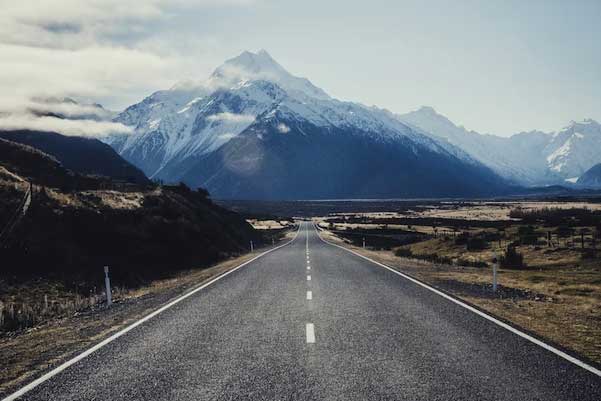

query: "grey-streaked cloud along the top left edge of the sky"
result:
(0, 0), (254, 48)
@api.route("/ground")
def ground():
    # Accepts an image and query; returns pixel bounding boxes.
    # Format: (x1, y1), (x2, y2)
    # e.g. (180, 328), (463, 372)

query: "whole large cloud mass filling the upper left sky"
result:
(0, 0), (253, 135)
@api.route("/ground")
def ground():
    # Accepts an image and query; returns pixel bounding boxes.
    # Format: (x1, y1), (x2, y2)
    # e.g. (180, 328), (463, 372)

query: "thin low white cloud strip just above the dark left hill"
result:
(0, 114), (132, 137)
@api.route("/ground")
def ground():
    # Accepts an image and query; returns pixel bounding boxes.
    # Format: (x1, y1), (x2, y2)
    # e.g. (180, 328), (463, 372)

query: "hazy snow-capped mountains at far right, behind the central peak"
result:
(398, 107), (601, 185)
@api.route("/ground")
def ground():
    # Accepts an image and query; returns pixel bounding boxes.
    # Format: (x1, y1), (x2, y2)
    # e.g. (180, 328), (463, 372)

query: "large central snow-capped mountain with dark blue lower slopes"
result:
(106, 50), (505, 198)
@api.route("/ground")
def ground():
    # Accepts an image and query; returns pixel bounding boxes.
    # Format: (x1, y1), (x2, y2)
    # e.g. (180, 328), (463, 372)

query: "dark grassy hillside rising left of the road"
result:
(0, 139), (277, 331)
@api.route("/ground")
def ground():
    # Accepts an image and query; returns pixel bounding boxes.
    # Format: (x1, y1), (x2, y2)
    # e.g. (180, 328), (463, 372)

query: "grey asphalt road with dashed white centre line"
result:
(8, 223), (601, 401)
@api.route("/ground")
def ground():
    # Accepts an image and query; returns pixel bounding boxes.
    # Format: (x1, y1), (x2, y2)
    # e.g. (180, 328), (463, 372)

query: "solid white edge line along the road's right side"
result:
(313, 224), (601, 377)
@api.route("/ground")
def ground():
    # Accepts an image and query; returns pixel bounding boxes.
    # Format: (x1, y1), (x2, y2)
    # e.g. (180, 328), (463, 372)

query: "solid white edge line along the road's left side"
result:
(2, 224), (301, 401)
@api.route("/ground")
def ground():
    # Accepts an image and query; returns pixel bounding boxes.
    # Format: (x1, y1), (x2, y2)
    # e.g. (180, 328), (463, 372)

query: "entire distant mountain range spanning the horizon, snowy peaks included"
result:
(9, 50), (601, 200)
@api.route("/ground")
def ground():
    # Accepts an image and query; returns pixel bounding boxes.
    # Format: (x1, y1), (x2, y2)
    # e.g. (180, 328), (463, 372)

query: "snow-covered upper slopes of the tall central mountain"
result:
(106, 50), (478, 180)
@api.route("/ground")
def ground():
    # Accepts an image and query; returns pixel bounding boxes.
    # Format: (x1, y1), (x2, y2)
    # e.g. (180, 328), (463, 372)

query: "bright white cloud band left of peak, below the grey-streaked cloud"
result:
(0, 44), (174, 108)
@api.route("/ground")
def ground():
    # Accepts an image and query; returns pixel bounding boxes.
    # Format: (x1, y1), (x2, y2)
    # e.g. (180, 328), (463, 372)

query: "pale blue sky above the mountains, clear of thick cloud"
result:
(0, 0), (601, 135)
